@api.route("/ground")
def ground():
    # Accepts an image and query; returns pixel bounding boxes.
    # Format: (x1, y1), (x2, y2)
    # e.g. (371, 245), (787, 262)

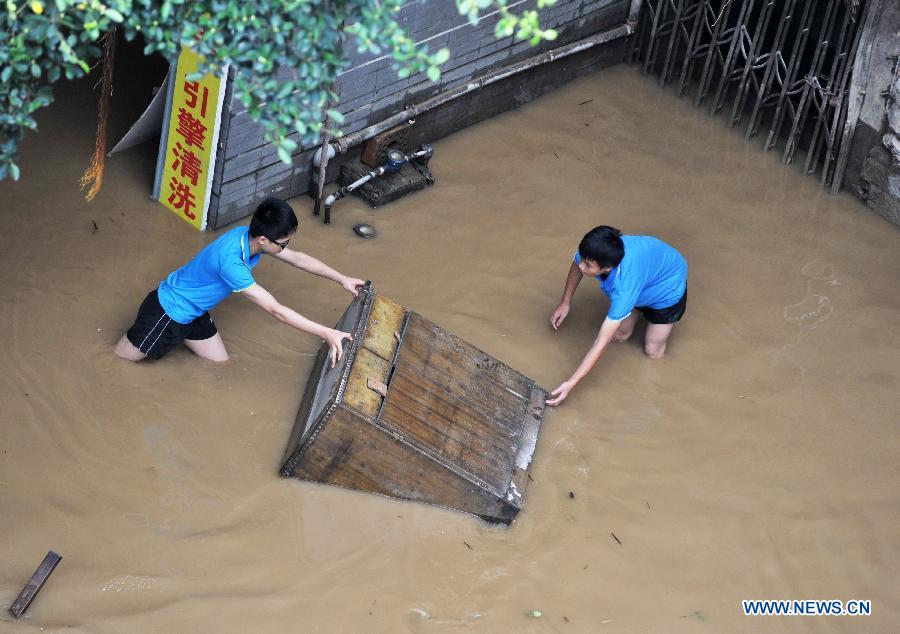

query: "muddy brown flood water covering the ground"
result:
(0, 67), (900, 633)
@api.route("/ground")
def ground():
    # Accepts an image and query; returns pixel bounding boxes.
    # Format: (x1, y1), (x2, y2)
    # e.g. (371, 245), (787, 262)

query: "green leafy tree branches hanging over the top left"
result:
(0, 0), (556, 180)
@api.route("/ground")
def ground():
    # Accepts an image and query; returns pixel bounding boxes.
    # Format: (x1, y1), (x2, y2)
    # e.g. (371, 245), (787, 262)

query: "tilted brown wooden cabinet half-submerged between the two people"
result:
(281, 284), (547, 524)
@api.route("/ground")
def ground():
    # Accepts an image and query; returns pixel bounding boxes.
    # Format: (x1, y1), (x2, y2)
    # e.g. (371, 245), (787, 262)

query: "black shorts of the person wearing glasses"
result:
(125, 290), (218, 359)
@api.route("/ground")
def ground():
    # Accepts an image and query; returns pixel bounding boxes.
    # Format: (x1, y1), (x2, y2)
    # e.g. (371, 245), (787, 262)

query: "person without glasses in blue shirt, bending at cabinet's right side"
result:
(547, 226), (687, 405)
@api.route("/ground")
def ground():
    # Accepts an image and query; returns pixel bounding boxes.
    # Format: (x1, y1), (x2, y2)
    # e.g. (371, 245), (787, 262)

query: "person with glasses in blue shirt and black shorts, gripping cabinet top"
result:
(115, 198), (364, 366)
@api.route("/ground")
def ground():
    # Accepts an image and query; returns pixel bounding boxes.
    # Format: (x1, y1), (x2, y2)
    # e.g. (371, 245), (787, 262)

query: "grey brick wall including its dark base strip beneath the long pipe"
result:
(209, 0), (629, 229)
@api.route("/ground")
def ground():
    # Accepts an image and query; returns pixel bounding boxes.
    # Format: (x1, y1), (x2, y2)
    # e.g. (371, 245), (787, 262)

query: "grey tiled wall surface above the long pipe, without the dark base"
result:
(210, 0), (628, 228)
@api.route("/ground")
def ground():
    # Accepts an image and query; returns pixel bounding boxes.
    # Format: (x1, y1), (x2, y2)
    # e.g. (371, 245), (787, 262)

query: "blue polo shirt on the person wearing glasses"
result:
(157, 227), (260, 324)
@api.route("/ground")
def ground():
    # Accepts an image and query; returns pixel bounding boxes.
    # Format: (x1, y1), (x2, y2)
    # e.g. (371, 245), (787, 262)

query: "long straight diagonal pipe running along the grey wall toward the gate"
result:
(331, 23), (640, 154)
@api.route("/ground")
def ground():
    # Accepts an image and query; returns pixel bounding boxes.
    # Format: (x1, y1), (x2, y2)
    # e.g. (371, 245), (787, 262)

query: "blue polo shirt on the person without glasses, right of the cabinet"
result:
(575, 236), (687, 321)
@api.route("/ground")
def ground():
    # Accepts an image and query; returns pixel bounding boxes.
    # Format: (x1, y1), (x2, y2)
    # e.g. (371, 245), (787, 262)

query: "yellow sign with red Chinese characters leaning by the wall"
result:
(158, 47), (225, 231)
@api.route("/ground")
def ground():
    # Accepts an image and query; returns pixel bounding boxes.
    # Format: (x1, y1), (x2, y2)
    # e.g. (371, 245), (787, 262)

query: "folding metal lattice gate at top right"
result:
(632, 0), (865, 191)
